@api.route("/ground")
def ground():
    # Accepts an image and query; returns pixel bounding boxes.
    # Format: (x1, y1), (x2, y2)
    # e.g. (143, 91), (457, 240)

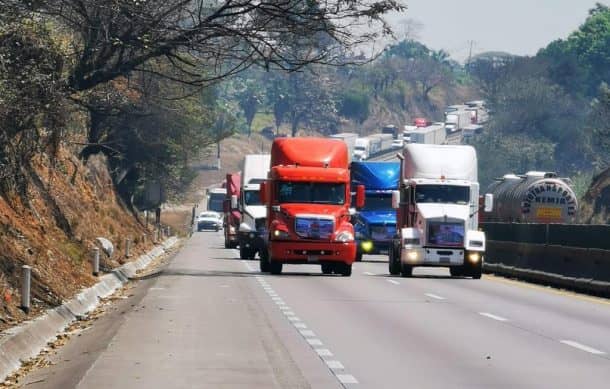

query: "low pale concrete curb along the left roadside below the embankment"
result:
(0, 237), (178, 382)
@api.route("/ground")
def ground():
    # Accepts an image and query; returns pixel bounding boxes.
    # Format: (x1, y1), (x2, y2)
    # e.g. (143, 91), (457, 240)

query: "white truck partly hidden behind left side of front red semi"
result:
(231, 154), (271, 259)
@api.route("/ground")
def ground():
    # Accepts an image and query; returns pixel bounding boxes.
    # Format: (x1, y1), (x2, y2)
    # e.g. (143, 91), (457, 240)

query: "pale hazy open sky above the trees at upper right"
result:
(389, 0), (608, 61)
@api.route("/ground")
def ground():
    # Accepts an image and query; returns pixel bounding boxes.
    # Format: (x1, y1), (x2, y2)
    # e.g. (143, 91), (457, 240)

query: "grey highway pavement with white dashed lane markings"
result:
(24, 232), (610, 388)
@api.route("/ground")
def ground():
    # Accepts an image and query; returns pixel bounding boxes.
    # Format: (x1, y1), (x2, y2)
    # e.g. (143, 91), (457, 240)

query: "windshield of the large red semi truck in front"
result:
(278, 182), (345, 204)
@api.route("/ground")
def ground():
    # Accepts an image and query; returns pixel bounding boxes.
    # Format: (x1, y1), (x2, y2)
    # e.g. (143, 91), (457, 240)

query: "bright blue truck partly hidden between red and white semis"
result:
(351, 162), (400, 261)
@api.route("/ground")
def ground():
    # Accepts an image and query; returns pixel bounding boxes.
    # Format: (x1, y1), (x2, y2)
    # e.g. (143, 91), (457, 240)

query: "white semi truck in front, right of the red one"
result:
(389, 144), (493, 278)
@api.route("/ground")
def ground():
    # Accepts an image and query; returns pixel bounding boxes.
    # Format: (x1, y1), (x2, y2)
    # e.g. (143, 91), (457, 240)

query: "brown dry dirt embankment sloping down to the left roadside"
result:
(0, 150), (152, 329)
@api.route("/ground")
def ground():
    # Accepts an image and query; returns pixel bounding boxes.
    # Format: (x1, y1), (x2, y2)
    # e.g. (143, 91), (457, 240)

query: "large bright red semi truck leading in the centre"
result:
(260, 138), (364, 276)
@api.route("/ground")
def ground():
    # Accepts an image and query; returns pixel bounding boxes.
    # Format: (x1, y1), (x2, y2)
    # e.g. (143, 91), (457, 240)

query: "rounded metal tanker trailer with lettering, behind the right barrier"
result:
(482, 171), (578, 223)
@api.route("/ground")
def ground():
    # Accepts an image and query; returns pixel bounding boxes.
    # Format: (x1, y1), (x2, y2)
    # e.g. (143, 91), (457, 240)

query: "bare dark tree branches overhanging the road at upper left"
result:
(0, 0), (404, 91)
